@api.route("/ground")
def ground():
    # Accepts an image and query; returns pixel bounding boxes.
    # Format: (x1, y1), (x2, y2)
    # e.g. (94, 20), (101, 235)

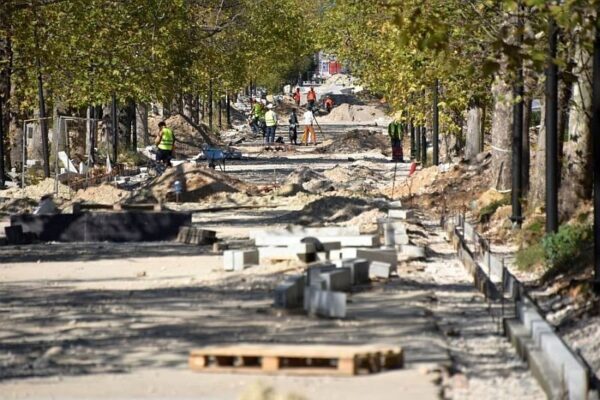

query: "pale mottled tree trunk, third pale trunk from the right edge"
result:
(492, 78), (513, 190)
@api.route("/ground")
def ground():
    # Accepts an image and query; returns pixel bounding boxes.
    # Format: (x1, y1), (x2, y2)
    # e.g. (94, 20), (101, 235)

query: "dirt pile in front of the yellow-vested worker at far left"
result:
(148, 163), (256, 202)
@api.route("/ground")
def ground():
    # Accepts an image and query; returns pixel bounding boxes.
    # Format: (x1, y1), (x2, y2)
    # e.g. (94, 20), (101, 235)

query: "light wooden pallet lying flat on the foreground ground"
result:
(189, 344), (403, 376)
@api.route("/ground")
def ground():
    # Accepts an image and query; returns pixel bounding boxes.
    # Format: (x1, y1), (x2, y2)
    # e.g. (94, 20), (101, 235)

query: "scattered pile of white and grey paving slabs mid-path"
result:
(223, 202), (425, 318)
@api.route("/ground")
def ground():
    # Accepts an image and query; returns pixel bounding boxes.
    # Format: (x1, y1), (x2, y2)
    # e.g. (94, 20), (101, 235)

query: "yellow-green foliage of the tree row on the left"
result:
(0, 0), (316, 178)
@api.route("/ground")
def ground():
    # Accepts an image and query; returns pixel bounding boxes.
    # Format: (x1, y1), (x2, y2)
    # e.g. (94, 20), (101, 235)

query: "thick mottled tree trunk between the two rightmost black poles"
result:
(559, 39), (592, 218)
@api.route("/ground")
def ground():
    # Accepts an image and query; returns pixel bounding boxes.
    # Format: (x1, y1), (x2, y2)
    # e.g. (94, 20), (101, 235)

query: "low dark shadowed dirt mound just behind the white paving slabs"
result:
(282, 196), (379, 225)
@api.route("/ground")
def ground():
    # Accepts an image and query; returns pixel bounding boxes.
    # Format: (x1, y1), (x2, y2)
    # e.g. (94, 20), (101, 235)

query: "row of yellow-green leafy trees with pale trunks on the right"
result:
(321, 0), (600, 223)
